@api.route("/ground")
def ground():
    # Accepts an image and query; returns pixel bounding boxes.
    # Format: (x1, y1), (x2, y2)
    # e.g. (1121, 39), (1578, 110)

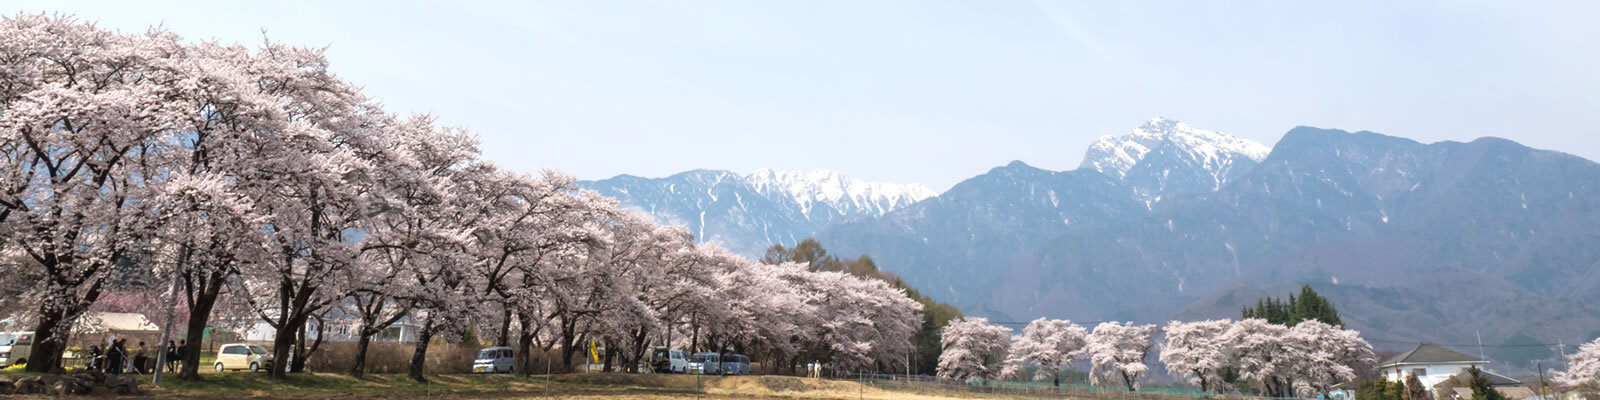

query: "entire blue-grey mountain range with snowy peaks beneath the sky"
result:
(586, 118), (1600, 368)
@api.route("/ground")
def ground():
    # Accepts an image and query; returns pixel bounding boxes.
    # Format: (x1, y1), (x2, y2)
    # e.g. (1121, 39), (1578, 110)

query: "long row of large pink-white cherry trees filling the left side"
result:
(0, 14), (922, 379)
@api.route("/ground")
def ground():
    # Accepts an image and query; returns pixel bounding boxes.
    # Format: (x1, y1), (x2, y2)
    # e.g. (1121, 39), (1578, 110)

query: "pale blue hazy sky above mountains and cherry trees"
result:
(8, 0), (1600, 190)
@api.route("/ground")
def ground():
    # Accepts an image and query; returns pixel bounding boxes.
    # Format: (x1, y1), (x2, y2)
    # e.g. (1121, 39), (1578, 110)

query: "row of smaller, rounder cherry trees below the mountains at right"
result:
(939, 318), (1376, 397)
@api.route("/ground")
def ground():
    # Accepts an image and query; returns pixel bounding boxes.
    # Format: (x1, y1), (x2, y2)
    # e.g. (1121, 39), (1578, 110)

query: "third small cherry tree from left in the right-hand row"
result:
(1083, 322), (1155, 392)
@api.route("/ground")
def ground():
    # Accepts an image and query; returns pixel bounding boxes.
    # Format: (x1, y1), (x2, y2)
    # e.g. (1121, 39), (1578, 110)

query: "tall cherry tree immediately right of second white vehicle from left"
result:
(214, 36), (400, 378)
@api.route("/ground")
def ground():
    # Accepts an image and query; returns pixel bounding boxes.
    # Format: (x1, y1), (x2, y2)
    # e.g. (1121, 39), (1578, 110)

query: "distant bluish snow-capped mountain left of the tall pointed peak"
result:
(578, 168), (934, 256)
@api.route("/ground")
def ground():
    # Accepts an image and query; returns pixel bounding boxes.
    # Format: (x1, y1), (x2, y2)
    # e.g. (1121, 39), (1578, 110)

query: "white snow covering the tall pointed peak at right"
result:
(1078, 117), (1272, 178)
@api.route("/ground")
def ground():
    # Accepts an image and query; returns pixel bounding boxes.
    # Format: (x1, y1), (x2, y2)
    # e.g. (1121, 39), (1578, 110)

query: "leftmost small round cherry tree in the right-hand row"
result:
(938, 317), (1011, 381)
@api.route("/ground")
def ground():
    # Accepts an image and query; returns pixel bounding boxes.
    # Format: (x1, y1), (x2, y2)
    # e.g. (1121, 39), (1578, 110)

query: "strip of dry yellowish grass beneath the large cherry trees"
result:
(0, 373), (1024, 400)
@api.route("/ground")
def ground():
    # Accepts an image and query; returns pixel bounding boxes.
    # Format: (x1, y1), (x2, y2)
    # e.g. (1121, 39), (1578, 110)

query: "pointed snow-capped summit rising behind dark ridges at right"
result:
(1078, 117), (1272, 205)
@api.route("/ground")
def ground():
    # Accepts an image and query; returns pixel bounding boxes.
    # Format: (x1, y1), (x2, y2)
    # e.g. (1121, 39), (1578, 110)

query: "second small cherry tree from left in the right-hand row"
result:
(1005, 318), (1088, 387)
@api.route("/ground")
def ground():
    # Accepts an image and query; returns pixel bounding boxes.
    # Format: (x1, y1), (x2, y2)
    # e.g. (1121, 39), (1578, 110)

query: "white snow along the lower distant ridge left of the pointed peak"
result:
(744, 168), (938, 218)
